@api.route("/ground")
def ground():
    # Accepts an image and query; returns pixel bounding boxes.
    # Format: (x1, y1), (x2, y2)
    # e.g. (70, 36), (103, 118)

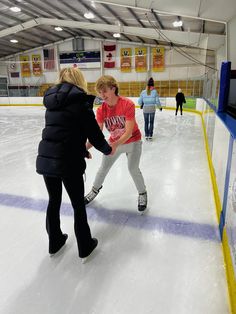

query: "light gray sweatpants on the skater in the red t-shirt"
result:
(93, 140), (146, 193)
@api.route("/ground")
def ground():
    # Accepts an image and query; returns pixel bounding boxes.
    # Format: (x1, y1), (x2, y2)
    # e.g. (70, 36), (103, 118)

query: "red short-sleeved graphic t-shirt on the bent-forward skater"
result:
(96, 96), (141, 144)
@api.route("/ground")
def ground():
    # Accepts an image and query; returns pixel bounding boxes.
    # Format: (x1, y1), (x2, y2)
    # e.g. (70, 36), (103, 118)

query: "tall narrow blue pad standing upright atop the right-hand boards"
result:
(217, 61), (231, 112)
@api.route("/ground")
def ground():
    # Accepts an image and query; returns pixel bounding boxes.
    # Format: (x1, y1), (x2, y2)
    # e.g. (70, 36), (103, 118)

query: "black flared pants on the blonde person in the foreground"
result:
(44, 175), (92, 257)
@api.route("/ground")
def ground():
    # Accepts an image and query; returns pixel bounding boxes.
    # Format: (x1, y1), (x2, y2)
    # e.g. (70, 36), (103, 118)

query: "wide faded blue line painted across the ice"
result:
(0, 193), (220, 242)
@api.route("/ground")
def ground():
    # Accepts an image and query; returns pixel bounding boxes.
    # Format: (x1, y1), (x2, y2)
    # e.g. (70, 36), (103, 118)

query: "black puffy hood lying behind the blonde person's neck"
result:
(43, 83), (84, 110)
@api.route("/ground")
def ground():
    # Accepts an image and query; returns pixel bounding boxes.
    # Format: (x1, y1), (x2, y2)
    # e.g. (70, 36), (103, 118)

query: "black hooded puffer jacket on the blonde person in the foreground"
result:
(36, 83), (111, 177)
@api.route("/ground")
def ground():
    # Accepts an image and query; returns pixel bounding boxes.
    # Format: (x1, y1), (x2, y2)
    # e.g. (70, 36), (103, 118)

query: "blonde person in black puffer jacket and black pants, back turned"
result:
(36, 68), (112, 258)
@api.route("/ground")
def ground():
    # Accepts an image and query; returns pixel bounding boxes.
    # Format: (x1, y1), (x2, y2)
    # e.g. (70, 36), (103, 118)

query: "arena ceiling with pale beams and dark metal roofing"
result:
(0, 0), (236, 58)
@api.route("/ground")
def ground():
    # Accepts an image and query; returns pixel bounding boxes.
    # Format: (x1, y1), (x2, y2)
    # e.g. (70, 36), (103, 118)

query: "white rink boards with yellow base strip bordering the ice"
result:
(0, 97), (236, 314)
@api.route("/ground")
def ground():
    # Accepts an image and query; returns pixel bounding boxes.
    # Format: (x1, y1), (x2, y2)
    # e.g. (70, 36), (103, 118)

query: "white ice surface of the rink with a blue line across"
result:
(0, 107), (230, 314)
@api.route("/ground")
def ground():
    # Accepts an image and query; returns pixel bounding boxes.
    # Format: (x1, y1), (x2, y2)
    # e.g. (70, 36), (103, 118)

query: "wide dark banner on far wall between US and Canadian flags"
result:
(59, 50), (101, 69)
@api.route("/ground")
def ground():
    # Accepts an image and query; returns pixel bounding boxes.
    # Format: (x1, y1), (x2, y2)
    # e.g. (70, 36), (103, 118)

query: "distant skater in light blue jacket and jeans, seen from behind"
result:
(138, 77), (162, 140)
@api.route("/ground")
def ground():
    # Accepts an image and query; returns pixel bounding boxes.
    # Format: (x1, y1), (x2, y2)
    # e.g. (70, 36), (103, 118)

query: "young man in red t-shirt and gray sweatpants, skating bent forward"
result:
(85, 75), (147, 214)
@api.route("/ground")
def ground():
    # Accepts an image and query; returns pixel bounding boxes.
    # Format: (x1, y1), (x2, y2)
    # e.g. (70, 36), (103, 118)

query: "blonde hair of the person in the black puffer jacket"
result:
(57, 68), (88, 93)
